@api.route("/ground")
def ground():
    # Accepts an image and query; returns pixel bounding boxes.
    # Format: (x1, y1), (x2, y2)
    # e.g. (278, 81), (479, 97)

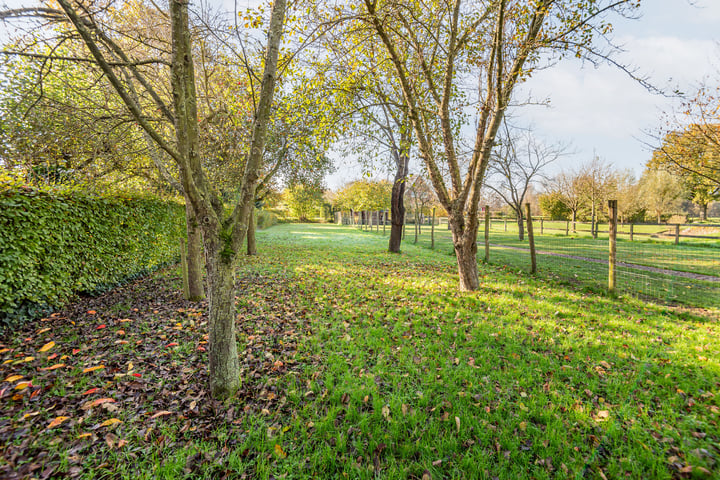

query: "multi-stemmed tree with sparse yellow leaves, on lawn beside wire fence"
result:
(352, 0), (633, 290)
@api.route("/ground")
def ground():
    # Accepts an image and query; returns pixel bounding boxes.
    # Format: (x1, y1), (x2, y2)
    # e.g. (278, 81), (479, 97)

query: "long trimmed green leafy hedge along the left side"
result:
(0, 181), (185, 330)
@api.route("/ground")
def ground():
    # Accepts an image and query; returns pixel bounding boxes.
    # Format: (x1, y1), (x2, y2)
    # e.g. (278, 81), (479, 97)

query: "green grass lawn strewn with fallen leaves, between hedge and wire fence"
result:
(0, 225), (720, 479)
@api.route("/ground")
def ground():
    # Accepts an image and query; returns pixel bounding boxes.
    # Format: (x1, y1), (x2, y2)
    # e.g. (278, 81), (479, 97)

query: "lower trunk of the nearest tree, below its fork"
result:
(206, 244), (240, 398)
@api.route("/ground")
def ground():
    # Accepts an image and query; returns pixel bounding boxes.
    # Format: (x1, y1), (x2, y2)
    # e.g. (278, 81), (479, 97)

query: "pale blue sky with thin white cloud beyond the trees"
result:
(327, 0), (720, 188)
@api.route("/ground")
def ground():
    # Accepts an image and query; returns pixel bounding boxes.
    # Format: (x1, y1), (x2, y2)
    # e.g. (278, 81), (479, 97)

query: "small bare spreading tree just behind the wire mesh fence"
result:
(486, 123), (562, 240)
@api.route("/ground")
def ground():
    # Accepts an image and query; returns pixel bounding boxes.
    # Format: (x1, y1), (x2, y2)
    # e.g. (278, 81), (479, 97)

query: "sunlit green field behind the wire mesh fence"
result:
(396, 221), (720, 308)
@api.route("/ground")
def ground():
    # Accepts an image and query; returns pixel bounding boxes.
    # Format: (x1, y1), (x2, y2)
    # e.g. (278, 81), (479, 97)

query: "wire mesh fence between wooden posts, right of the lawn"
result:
(344, 209), (720, 308)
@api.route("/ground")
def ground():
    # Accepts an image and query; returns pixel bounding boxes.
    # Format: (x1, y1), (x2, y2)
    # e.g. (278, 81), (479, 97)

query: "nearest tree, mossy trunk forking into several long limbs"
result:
(2, 0), (286, 398)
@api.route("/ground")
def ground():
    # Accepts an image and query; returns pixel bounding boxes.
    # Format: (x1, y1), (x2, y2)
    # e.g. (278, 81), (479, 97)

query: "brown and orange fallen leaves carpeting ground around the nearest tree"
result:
(0, 273), (303, 479)
